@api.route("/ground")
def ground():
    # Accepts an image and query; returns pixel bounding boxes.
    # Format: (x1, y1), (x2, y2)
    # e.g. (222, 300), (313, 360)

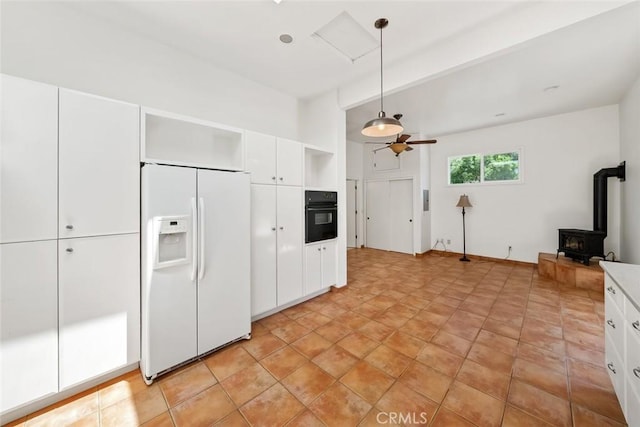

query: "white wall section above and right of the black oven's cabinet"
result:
(299, 91), (347, 287)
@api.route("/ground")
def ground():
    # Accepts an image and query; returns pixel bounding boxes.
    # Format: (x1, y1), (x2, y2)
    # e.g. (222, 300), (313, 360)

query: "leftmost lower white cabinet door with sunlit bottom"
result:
(0, 240), (58, 412)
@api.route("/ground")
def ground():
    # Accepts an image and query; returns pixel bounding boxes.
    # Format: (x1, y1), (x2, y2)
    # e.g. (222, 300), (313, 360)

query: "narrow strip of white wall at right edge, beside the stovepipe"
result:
(620, 78), (640, 264)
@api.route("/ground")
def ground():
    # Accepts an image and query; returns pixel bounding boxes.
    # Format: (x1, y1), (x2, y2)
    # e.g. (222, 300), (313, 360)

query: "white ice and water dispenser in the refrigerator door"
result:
(153, 216), (192, 269)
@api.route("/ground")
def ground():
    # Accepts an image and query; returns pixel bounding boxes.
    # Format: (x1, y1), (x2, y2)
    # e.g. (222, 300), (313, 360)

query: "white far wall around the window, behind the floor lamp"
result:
(431, 105), (620, 262)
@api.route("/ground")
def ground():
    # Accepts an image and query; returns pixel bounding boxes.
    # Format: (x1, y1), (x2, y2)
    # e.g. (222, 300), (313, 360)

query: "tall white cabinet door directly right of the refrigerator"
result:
(251, 184), (278, 316)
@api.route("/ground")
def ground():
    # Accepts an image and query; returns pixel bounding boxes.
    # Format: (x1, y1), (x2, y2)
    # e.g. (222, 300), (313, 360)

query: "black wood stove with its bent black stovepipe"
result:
(556, 162), (625, 265)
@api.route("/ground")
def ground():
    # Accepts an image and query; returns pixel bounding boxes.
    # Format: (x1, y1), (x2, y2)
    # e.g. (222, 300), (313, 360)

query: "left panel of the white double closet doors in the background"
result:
(366, 181), (391, 250)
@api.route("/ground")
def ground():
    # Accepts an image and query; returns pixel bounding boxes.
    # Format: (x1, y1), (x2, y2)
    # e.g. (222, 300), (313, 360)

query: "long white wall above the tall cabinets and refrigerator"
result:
(0, 2), (298, 139)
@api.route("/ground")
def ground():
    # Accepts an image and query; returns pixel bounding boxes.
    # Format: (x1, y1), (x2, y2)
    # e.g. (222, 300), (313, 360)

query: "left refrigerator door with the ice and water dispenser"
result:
(140, 164), (197, 380)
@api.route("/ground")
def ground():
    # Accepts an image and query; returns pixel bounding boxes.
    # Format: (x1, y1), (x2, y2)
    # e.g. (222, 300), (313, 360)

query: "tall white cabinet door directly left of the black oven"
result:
(277, 186), (304, 305)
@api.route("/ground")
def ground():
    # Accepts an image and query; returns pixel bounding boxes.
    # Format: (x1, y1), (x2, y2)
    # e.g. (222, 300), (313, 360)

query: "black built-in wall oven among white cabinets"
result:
(304, 190), (338, 243)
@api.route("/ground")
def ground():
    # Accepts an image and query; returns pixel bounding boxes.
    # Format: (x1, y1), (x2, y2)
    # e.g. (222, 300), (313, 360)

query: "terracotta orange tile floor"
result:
(3, 249), (624, 427)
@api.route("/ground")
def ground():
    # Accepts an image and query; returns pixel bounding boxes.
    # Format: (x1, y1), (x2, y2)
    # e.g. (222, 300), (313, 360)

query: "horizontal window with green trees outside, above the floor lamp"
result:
(449, 151), (521, 185)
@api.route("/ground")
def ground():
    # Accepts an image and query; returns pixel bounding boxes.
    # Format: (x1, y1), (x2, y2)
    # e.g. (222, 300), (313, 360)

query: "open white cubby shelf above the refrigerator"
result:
(140, 108), (244, 171)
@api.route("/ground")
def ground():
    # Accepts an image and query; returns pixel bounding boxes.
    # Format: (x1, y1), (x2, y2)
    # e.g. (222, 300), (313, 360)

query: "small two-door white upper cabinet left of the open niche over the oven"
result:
(245, 131), (302, 186)
